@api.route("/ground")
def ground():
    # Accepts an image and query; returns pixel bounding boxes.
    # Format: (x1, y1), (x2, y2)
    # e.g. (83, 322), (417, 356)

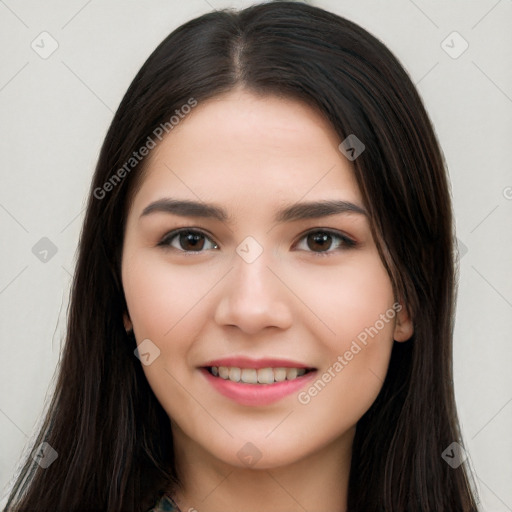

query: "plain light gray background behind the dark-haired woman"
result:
(0, 0), (512, 512)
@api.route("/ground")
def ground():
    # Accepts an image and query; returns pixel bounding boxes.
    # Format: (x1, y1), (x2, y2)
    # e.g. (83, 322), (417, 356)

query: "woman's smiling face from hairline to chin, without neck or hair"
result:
(122, 90), (412, 468)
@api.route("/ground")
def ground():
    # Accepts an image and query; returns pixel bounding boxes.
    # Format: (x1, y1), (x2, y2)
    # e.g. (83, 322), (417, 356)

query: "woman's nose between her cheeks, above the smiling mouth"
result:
(215, 251), (293, 334)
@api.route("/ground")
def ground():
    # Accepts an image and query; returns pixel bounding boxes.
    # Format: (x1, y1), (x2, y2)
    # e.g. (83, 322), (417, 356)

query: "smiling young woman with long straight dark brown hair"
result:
(7, 2), (477, 512)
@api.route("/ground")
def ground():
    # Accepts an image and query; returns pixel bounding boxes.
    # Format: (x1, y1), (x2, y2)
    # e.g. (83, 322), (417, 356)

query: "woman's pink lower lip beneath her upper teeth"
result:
(201, 368), (316, 406)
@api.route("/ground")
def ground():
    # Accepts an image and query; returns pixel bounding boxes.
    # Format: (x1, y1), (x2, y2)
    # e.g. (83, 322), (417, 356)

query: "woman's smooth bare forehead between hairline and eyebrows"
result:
(130, 90), (361, 213)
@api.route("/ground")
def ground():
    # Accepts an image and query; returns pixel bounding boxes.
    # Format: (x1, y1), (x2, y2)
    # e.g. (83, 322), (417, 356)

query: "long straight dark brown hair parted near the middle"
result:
(7, 2), (477, 512)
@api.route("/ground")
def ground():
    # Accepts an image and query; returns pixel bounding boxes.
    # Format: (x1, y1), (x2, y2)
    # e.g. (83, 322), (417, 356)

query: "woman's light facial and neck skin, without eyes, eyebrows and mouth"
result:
(122, 89), (413, 512)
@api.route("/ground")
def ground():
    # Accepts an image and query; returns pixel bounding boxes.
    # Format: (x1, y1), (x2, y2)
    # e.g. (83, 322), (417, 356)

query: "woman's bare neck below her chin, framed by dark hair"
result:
(172, 428), (355, 512)
